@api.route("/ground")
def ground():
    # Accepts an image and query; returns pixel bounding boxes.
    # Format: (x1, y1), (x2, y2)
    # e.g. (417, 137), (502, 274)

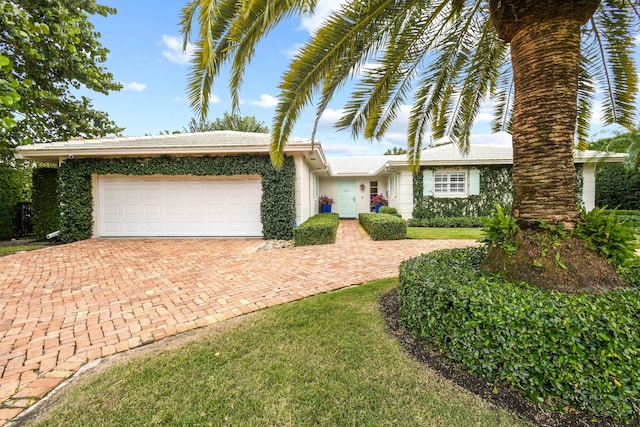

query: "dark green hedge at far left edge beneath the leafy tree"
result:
(0, 164), (22, 239)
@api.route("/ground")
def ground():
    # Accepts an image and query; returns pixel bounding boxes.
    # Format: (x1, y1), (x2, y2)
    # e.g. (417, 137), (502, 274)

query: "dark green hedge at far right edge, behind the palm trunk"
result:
(596, 165), (640, 210)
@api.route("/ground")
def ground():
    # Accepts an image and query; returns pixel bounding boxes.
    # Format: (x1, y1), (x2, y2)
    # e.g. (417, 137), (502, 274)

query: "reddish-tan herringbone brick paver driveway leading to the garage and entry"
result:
(0, 221), (473, 425)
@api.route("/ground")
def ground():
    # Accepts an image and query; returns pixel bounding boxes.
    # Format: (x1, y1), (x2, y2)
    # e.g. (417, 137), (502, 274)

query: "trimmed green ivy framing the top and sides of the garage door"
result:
(58, 155), (295, 242)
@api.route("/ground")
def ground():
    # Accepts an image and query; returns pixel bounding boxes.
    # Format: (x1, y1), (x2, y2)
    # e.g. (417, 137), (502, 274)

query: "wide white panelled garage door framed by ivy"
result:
(96, 175), (262, 237)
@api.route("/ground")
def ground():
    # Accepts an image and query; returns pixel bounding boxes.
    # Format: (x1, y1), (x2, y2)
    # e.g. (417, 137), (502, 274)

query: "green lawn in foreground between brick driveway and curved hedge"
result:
(28, 279), (525, 427)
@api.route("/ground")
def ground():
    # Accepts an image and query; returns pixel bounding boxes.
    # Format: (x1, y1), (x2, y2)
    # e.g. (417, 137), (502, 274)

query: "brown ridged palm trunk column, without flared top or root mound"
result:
(511, 19), (580, 229)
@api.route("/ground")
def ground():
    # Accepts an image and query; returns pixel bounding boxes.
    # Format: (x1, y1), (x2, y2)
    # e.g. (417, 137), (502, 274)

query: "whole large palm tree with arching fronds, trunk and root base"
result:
(181, 0), (640, 288)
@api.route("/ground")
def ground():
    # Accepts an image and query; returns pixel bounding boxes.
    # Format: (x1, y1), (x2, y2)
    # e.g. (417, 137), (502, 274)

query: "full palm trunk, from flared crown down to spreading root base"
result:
(483, 0), (621, 292)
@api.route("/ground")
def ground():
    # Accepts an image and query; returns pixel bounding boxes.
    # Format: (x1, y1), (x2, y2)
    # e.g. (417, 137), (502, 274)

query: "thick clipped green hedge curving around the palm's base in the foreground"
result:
(398, 248), (640, 425)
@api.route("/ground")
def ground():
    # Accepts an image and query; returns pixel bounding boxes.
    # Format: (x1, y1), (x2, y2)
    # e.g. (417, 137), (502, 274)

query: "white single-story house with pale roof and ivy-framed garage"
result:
(17, 131), (623, 241)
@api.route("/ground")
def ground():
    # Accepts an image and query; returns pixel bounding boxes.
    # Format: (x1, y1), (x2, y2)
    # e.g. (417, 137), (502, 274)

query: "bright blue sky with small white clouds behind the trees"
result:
(81, 0), (636, 156)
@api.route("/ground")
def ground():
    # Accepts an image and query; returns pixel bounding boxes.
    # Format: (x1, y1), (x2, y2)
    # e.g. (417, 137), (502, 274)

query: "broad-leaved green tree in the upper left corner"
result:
(0, 0), (123, 157)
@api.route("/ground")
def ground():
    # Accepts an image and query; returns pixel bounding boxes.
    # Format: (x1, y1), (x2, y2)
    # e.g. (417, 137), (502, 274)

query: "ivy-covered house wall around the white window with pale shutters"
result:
(413, 165), (584, 219)
